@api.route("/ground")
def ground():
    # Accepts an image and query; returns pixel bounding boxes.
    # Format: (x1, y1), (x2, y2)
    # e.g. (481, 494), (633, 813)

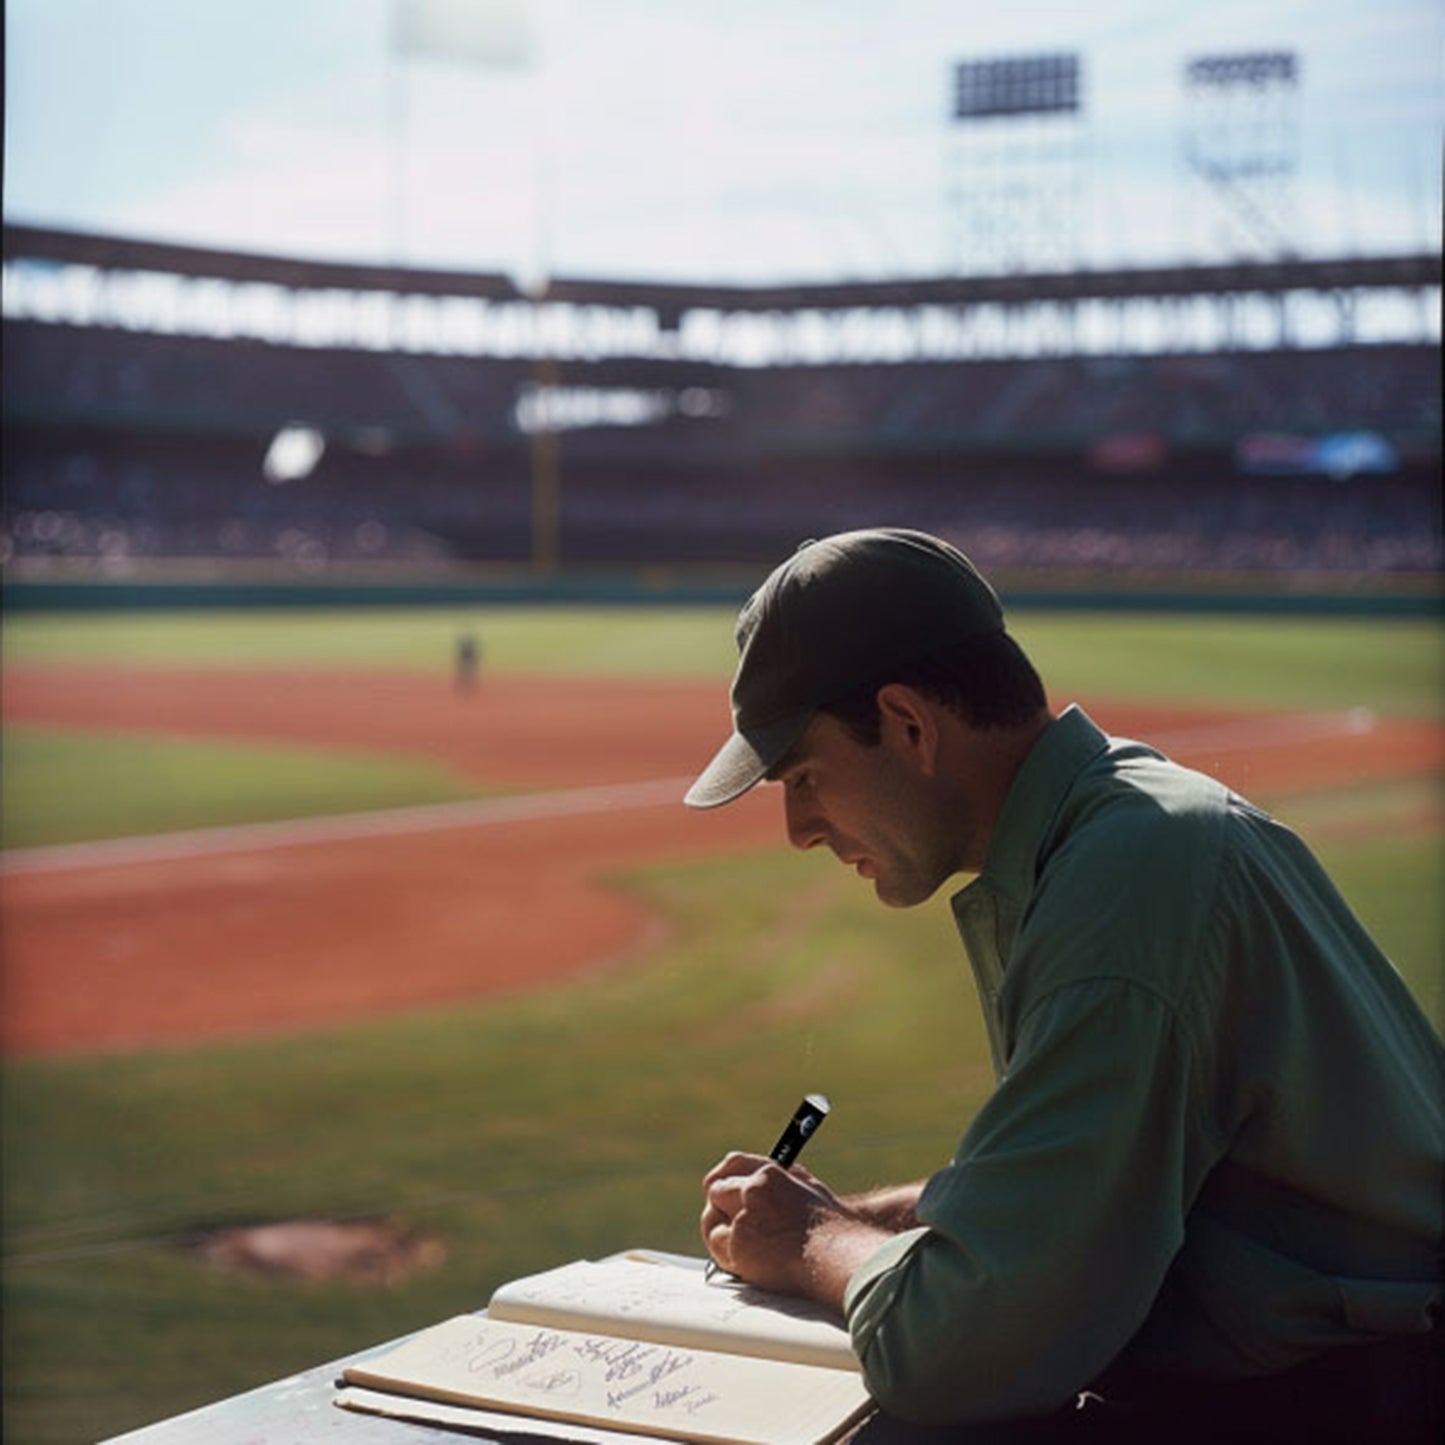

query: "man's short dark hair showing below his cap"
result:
(819, 631), (1046, 747)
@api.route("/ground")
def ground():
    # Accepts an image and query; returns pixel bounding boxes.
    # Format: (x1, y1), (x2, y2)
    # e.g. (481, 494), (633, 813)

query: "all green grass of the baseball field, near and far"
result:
(0, 610), (1445, 1445)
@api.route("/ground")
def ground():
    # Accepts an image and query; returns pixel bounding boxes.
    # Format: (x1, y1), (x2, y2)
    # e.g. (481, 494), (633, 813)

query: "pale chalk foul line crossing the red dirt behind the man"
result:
(0, 708), (1376, 874)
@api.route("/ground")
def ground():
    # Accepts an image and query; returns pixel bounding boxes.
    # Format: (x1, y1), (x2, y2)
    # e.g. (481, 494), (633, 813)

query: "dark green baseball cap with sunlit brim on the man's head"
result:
(683, 527), (1003, 808)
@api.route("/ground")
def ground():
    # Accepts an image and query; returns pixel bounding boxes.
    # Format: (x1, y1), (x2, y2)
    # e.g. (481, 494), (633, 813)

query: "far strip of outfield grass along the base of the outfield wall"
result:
(4, 607), (1445, 717)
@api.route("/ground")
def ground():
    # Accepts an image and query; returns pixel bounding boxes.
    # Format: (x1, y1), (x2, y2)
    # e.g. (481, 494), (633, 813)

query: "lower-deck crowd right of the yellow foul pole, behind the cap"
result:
(549, 461), (1445, 574)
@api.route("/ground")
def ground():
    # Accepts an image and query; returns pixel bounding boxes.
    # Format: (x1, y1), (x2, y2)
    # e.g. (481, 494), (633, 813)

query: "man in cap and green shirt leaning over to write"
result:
(688, 530), (1445, 1439)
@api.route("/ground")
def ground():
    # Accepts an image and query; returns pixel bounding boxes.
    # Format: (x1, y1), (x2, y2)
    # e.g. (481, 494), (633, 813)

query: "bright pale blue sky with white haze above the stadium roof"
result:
(4, 0), (1445, 282)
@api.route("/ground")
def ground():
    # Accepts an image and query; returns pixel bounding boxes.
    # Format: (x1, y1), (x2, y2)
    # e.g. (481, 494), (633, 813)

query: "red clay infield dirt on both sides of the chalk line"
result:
(0, 666), (1445, 1055)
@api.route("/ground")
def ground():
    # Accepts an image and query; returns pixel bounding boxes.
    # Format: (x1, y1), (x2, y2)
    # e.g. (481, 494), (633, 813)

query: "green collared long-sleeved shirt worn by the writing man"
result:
(847, 708), (1445, 1422)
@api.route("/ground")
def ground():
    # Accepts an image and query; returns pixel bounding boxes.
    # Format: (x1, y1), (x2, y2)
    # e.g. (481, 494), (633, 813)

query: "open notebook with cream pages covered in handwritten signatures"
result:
(337, 1251), (871, 1445)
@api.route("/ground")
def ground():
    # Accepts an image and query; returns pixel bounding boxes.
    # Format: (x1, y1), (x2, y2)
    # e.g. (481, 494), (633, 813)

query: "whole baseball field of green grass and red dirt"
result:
(0, 607), (1445, 1445)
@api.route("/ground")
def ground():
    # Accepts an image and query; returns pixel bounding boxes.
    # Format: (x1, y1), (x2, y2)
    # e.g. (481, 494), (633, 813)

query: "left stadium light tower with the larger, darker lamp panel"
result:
(948, 53), (1084, 276)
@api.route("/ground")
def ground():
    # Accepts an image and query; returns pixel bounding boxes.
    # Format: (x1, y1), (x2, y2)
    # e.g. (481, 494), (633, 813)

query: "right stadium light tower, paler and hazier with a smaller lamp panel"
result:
(1183, 51), (1299, 260)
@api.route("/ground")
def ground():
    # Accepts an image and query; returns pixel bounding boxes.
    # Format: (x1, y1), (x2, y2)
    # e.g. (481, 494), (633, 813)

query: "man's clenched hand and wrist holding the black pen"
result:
(702, 1153), (889, 1314)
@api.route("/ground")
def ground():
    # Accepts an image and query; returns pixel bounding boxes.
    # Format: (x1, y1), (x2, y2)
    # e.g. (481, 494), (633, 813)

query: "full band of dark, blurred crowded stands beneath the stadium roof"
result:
(0, 322), (1445, 572)
